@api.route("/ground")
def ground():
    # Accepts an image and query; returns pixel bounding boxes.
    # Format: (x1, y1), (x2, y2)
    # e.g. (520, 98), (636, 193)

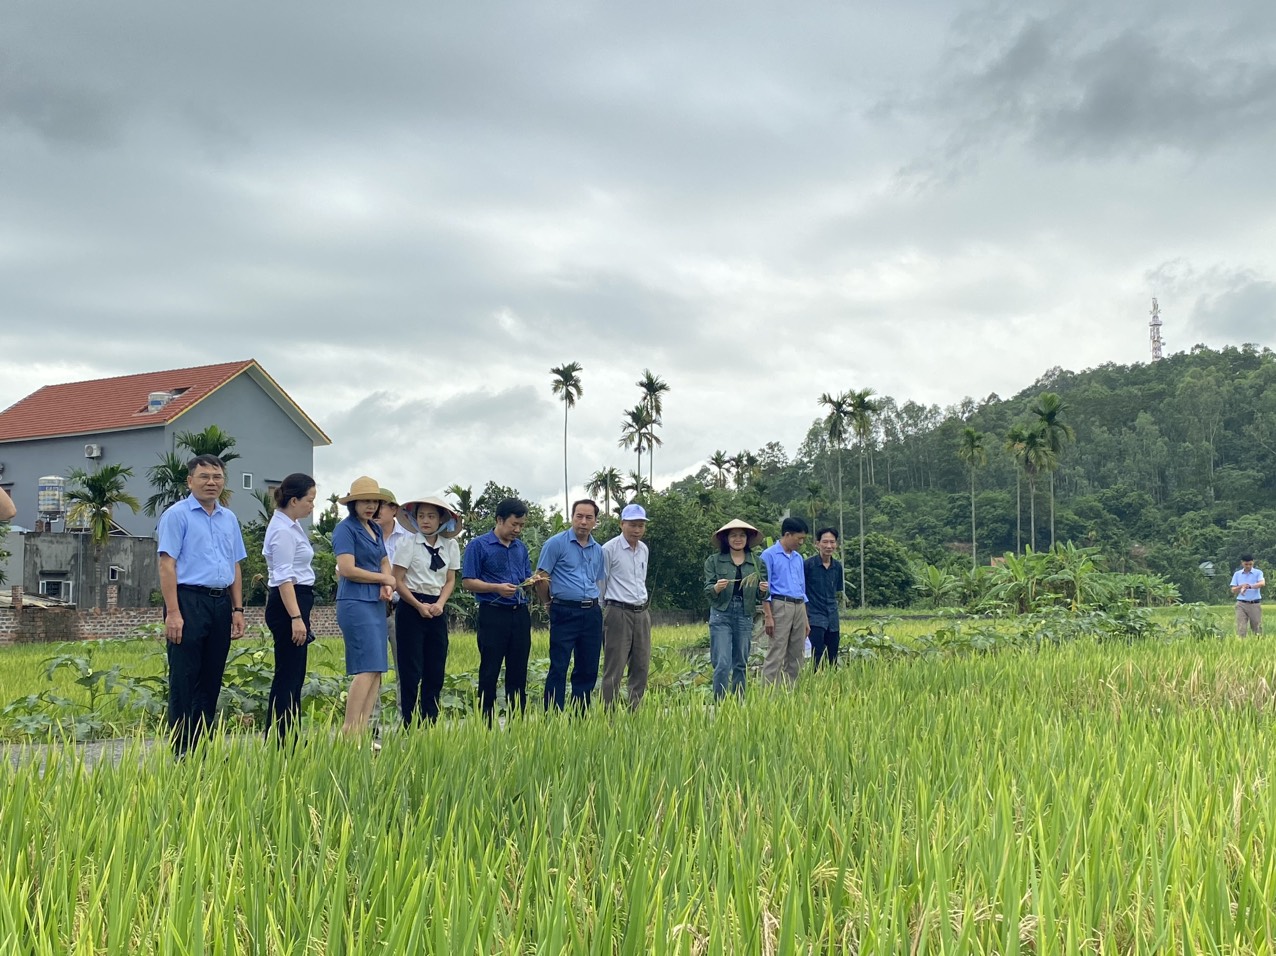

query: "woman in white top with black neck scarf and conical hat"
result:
(393, 495), (461, 728)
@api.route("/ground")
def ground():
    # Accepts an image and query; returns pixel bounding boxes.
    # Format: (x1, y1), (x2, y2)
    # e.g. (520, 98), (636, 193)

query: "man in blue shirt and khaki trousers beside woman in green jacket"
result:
(762, 518), (810, 684)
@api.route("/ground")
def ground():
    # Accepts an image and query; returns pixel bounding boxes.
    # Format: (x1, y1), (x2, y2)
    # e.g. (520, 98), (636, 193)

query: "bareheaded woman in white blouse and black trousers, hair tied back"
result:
(262, 472), (315, 743)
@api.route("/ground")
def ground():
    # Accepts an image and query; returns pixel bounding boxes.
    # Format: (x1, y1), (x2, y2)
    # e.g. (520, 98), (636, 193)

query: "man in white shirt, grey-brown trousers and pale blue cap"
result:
(602, 504), (651, 710)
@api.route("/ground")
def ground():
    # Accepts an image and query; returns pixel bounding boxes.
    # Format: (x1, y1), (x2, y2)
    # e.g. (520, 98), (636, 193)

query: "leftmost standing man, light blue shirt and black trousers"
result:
(157, 454), (246, 757)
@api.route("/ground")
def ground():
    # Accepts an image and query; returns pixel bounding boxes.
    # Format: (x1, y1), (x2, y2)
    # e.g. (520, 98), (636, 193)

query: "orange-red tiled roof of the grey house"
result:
(0, 359), (319, 442)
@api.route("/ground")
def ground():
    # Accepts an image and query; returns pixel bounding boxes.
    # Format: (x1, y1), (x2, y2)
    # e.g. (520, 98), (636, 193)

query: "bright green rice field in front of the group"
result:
(0, 622), (1276, 955)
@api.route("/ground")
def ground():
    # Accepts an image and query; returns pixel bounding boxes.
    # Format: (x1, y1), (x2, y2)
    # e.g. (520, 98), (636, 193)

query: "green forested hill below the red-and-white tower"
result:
(698, 345), (1276, 600)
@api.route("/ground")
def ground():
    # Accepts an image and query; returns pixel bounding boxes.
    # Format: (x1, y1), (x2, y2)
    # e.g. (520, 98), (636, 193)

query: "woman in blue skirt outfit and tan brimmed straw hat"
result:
(332, 475), (394, 734)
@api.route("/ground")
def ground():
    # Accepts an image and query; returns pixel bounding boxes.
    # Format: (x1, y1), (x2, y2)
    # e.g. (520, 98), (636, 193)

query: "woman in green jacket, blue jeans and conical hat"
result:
(704, 518), (769, 699)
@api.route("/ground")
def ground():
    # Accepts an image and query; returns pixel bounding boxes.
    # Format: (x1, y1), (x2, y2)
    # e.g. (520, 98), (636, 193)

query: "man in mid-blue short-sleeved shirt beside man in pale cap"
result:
(536, 498), (607, 711)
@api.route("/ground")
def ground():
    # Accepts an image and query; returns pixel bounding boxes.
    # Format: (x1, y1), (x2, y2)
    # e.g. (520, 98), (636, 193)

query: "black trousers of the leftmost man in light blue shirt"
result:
(168, 585), (231, 756)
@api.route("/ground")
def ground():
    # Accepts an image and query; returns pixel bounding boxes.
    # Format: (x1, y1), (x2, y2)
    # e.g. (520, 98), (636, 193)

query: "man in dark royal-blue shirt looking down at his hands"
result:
(461, 498), (532, 726)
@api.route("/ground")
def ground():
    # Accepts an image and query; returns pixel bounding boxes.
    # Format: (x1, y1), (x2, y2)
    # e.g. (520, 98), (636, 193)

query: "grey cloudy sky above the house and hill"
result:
(0, 0), (1276, 515)
